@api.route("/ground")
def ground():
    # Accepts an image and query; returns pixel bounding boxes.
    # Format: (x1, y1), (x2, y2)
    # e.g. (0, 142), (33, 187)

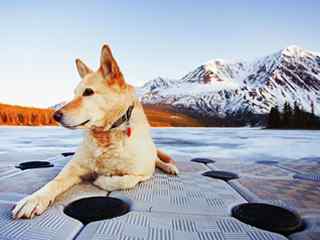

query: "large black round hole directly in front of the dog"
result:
(64, 197), (130, 224)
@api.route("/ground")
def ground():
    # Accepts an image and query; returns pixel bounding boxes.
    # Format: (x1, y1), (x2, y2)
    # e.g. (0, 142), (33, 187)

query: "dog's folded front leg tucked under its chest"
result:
(93, 175), (151, 192)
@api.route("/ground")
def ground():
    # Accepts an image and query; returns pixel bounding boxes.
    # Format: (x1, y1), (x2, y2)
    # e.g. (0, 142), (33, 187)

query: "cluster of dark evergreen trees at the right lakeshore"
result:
(267, 102), (320, 129)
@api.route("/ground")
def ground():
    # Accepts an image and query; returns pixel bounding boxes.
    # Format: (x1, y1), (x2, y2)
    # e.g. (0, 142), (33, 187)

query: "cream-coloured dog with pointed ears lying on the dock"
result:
(12, 44), (178, 219)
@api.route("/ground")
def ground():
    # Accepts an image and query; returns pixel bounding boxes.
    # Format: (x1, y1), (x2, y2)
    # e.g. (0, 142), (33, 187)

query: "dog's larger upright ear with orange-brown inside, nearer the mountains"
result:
(99, 44), (125, 87)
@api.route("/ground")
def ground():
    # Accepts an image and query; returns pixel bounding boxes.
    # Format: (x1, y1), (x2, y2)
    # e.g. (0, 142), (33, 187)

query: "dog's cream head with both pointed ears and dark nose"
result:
(53, 45), (133, 129)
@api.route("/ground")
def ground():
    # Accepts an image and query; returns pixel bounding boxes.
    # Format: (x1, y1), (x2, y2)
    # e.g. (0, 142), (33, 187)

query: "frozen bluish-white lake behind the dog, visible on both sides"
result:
(0, 127), (320, 165)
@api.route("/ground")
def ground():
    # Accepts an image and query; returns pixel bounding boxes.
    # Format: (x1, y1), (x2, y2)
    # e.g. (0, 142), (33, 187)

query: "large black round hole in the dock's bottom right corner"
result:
(231, 203), (303, 235)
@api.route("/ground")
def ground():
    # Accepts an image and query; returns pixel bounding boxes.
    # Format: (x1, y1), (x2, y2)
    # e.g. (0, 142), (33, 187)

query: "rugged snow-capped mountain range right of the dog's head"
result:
(139, 46), (320, 117)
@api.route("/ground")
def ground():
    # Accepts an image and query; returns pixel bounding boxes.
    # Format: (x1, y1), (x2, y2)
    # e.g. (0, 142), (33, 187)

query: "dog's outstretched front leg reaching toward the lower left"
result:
(12, 160), (88, 219)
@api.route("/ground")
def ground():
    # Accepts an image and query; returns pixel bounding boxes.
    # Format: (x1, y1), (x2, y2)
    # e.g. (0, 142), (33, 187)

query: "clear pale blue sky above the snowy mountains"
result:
(0, 0), (320, 107)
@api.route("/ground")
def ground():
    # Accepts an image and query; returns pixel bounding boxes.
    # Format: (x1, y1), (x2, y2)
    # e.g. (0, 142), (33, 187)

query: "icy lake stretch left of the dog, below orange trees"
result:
(0, 127), (82, 166)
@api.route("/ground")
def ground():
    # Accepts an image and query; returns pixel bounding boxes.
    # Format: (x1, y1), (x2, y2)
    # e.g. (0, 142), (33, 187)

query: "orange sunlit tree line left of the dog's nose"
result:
(0, 104), (57, 126)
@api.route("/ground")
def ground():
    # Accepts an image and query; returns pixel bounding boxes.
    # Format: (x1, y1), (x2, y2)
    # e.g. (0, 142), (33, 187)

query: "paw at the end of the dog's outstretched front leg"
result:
(12, 193), (52, 219)
